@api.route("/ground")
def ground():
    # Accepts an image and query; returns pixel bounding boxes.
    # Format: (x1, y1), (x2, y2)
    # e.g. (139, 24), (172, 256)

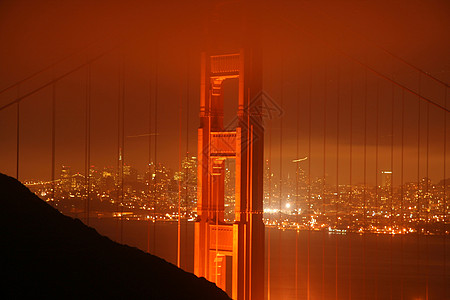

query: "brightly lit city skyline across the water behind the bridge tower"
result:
(25, 157), (450, 234)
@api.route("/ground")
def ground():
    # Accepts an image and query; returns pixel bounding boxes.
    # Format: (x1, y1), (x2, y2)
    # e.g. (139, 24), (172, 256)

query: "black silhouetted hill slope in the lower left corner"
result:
(0, 174), (229, 299)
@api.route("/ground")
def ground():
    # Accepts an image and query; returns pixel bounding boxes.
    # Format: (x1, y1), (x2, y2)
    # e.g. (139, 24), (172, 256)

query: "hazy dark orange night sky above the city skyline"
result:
(0, 0), (450, 185)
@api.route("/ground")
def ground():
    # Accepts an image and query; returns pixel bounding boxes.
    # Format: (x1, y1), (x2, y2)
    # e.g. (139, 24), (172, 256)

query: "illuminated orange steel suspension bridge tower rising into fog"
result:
(194, 47), (264, 300)
